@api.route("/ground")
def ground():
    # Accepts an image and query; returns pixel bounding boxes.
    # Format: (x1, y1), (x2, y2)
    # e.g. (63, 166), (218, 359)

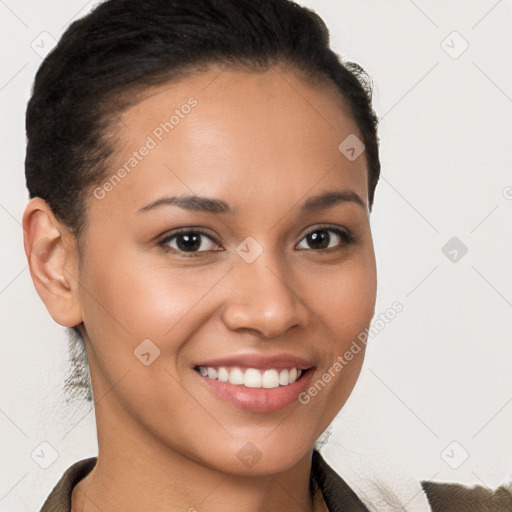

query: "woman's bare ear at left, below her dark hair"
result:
(23, 197), (82, 327)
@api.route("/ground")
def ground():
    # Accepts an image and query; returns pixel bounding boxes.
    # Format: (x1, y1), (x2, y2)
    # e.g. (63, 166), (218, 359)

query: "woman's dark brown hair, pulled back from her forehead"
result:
(25, 0), (380, 399)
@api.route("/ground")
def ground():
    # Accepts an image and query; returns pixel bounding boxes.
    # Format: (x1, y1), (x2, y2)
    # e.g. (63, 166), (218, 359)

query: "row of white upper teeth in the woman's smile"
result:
(195, 366), (302, 389)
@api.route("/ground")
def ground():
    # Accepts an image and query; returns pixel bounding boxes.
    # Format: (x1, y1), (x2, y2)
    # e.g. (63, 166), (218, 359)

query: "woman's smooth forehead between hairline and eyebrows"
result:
(87, 68), (367, 220)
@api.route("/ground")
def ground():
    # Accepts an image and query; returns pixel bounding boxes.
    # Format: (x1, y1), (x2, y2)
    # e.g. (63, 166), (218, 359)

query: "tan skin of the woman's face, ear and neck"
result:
(23, 68), (376, 512)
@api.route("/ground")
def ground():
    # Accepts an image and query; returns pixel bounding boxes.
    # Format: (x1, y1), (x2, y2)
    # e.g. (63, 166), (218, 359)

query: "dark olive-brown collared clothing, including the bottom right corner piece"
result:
(40, 450), (512, 512)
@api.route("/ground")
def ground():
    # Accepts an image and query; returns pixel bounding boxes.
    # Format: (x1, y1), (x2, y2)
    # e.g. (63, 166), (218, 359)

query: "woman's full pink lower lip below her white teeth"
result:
(194, 368), (314, 412)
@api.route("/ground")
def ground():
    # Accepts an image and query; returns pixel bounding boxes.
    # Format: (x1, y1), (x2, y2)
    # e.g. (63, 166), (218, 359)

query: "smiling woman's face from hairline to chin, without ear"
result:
(73, 68), (376, 474)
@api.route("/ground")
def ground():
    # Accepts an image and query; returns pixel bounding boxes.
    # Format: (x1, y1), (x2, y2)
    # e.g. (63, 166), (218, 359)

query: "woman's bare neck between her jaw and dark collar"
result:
(72, 412), (314, 512)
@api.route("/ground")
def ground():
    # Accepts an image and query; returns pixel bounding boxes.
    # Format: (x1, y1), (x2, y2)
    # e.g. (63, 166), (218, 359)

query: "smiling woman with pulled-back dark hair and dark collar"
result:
(23, 0), (512, 512)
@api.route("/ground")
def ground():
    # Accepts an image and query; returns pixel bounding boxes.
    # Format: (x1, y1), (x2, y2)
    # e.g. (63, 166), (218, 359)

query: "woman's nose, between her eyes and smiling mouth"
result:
(222, 255), (309, 338)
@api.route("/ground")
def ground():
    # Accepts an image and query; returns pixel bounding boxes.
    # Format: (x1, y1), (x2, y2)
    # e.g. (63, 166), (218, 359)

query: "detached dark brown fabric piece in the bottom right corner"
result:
(421, 481), (512, 512)
